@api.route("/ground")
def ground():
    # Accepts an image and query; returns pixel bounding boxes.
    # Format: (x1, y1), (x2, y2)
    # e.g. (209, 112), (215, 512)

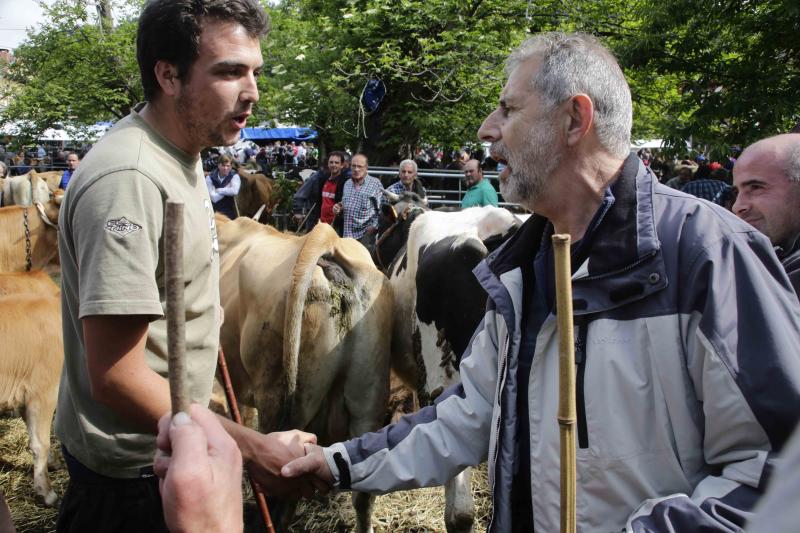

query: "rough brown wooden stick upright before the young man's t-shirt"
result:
(164, 200), (190, 415)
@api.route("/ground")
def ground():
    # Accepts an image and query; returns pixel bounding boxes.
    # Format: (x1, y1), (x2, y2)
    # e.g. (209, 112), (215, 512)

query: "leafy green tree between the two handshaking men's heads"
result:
(267, 0), (526, 163)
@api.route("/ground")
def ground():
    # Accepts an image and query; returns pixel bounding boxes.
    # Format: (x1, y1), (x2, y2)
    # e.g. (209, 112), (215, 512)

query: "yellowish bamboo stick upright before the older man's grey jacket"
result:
(552, 234), (577, 533)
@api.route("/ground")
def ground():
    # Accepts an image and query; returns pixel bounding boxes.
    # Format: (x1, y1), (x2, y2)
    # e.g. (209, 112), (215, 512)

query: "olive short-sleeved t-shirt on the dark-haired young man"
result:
(55, 102), (219, 478)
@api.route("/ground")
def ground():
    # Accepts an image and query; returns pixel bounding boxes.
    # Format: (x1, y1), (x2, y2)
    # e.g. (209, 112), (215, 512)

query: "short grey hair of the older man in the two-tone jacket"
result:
(505, 32), (633, 158)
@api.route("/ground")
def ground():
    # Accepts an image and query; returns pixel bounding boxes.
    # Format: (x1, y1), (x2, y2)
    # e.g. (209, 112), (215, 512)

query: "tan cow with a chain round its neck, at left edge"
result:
(0, 202), (60, 273)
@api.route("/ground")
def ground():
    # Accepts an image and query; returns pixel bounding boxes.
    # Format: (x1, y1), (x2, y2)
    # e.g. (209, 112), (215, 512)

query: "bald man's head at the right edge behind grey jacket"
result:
(733, 133), (800, 248)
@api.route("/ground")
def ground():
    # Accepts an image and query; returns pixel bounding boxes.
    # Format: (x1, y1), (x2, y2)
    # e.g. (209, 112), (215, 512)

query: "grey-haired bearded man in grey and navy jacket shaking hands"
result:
(282, 33), (800, 533)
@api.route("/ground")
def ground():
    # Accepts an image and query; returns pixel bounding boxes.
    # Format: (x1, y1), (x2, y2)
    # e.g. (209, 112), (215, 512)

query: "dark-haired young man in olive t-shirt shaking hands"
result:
(56, 0), (314, 532)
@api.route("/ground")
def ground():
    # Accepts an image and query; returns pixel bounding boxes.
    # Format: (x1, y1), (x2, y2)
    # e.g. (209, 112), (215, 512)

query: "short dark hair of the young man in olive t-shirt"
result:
(136, 0), (269, 101)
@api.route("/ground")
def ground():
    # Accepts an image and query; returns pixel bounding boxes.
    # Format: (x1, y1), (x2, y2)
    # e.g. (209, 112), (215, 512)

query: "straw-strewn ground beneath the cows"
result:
(0, 416), (490, 533)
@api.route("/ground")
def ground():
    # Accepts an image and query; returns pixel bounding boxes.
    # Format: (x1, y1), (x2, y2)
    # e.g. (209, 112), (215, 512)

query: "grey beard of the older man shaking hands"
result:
(499, 113), (563, 208)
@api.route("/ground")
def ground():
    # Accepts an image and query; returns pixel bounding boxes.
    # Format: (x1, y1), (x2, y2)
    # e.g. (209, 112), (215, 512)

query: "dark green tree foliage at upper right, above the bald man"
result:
(620, 0), (800, 155)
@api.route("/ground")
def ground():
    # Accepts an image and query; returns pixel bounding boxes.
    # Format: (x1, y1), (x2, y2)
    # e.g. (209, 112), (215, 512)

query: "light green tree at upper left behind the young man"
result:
(0, 0), (143, 145)
